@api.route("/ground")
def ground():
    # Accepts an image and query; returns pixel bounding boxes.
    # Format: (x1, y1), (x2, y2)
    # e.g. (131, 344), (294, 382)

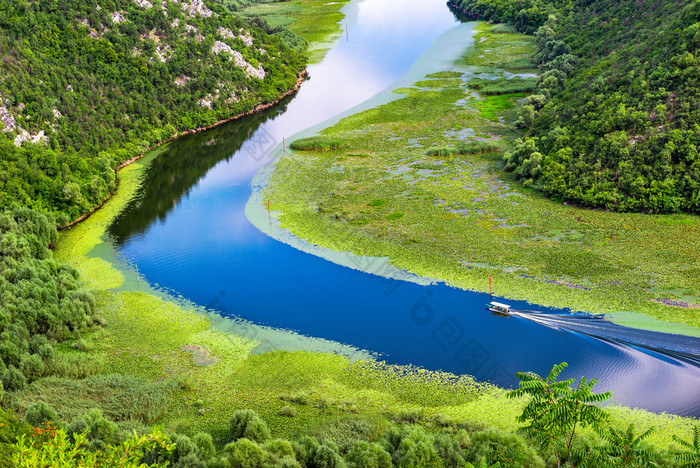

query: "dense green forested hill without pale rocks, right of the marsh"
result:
(452, 0), (700, 213)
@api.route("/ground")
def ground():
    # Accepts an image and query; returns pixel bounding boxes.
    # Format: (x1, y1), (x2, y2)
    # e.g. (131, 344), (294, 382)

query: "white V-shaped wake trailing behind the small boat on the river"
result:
(510, 310), (700, 367)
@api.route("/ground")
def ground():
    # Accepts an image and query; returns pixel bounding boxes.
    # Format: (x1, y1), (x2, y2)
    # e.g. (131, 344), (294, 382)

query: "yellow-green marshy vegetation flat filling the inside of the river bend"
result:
(264, 24), (700, 334)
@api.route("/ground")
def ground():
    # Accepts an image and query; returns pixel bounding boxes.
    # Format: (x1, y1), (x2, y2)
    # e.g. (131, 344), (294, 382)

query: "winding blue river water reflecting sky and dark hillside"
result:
(109, 0), (700, 416)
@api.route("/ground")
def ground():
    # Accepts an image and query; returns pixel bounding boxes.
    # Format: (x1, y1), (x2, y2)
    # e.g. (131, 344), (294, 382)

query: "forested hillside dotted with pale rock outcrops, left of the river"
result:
(0, 0), (304, 225)
